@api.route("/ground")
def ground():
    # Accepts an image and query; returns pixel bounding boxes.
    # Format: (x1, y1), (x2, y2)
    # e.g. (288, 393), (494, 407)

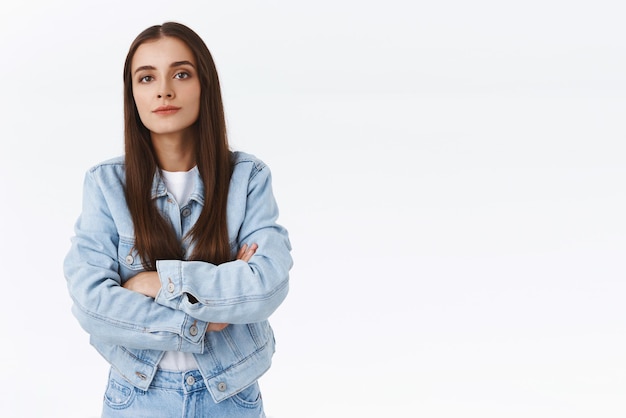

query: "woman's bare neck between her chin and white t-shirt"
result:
(151, 133), (196, 171)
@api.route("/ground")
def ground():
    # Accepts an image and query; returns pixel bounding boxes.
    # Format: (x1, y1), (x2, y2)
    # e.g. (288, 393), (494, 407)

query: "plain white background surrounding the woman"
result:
(0, 0), (626, 418)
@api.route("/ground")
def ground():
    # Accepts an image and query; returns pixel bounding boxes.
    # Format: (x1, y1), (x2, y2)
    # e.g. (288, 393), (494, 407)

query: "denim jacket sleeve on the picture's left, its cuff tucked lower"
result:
(64, 170), (207, 353)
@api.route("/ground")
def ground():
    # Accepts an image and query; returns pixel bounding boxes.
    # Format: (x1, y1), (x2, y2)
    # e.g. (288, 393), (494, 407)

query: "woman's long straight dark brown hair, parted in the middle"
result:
(124, 22), (232, 270)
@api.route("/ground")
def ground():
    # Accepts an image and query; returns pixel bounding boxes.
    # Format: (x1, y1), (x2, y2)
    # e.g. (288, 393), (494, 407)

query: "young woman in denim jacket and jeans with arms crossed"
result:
(64, 23), (292, 417)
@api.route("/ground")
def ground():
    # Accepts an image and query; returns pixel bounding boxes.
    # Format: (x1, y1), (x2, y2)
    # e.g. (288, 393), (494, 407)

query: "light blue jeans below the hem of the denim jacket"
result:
(102, 369), (265, 418)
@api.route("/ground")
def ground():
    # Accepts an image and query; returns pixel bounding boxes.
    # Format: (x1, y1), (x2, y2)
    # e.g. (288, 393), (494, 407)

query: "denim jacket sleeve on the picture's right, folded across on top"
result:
(156, 163), (293, 324)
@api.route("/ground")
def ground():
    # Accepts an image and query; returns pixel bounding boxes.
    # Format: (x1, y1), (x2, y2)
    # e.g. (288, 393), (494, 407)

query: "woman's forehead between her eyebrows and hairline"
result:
(131, 36), (196, 71)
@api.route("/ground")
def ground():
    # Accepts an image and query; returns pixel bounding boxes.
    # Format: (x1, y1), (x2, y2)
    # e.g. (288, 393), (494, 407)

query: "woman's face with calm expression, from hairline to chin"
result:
(131, 36), (201, 139)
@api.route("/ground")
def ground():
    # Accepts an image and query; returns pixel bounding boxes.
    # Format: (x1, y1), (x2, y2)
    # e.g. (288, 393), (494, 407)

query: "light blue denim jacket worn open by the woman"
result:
(64, 152), (292, 402)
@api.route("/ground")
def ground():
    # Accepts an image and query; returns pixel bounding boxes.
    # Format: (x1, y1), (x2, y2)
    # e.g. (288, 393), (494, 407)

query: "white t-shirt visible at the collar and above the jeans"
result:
(159, 167), (198, 371)
